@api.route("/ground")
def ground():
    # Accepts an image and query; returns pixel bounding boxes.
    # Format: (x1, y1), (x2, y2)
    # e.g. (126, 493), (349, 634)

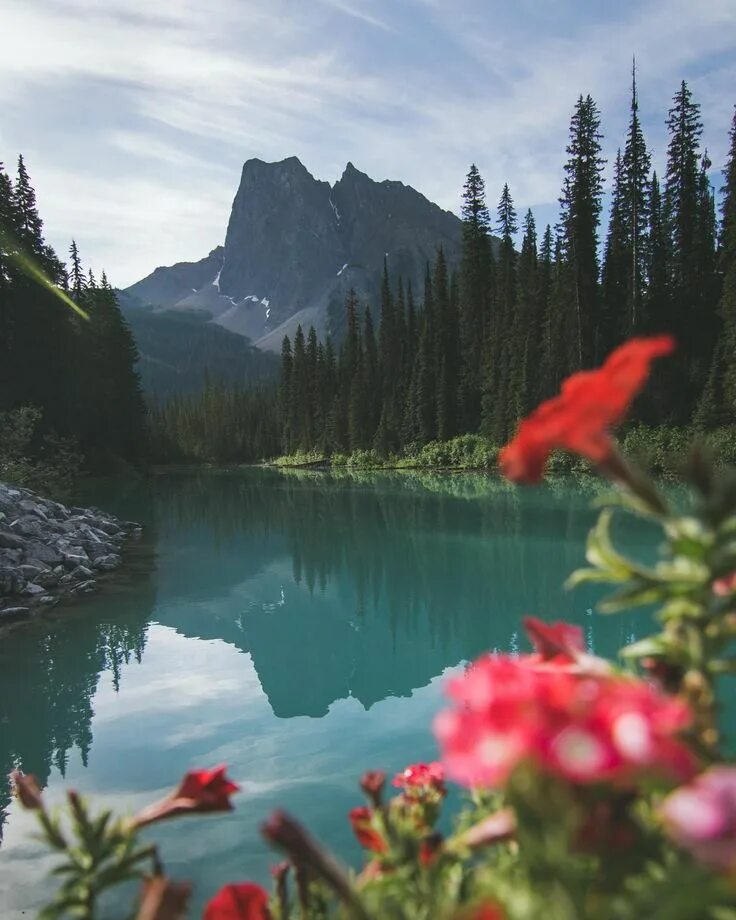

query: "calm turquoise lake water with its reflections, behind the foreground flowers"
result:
(0, 470), (647, 918)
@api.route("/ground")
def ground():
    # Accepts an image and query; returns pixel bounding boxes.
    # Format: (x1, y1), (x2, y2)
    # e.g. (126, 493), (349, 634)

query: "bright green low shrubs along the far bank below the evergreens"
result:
(271, 424), (736, 476)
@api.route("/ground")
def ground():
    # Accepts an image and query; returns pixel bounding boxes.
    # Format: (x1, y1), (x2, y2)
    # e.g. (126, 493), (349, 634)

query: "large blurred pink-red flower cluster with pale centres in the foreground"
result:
(435, 654), (694, 787)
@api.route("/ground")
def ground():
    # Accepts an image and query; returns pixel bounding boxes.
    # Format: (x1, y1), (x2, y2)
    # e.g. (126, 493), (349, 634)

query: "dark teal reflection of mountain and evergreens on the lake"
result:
(0, 470), (647, 840)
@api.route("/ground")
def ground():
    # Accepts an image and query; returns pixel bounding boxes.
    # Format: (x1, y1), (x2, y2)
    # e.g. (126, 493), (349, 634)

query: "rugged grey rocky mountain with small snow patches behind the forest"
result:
(124, 157), (462, 352)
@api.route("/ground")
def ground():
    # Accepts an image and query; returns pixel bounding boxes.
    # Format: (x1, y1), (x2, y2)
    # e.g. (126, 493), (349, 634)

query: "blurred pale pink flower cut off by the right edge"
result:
(662, 767), (736, 869)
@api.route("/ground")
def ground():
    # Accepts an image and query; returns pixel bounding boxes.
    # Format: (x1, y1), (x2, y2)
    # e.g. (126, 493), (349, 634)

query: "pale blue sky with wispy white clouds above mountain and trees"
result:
(0, 0), (736, 287)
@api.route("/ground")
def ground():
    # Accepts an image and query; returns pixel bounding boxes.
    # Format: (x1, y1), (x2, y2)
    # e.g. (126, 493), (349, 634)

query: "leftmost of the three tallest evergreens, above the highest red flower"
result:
(560, 96), (605, 368)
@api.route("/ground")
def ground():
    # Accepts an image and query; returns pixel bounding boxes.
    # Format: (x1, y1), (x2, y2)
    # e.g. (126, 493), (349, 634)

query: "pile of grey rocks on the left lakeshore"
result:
(0, 483), (141, 622)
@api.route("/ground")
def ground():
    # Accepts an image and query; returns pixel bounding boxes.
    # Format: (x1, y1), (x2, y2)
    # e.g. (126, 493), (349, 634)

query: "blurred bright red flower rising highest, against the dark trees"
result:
(499, 335), (675, 483)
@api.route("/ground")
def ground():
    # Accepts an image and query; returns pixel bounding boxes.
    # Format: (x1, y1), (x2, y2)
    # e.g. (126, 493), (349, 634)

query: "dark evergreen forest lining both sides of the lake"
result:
(0, 74), (736, 469)
